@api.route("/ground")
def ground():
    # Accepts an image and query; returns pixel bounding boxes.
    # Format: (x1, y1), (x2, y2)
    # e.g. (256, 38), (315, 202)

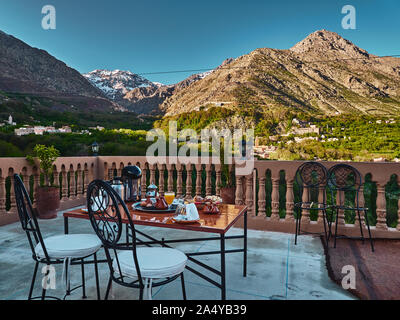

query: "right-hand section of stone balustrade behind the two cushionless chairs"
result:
(236, 161), (400, 238)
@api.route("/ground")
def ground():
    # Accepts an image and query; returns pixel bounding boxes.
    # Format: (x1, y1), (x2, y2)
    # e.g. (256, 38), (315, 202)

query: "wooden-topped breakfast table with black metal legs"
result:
(64, 203), (247, 300)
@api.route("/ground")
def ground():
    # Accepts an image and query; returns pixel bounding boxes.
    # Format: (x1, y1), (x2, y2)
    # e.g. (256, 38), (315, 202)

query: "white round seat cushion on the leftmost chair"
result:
(35, 234), (101, 259)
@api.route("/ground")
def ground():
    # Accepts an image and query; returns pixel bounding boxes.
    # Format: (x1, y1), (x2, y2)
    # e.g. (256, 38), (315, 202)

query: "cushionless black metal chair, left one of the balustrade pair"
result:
(294, 161), (328, 244)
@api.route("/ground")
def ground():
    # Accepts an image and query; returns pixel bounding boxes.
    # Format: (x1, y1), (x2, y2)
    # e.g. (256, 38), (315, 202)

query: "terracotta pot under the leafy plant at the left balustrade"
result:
(36, 187), (60, 219)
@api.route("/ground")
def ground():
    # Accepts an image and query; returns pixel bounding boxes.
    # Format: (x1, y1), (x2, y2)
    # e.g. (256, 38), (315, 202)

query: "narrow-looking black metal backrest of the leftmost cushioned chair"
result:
(13, 174), (50, 261)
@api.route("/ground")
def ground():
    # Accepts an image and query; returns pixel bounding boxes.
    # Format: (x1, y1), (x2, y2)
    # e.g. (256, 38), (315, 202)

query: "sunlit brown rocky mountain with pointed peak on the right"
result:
(160, 30), (400, 115)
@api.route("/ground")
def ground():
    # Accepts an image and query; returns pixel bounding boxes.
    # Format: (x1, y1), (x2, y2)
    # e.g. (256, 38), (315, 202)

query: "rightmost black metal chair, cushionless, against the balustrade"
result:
(328, 163), (374, 252)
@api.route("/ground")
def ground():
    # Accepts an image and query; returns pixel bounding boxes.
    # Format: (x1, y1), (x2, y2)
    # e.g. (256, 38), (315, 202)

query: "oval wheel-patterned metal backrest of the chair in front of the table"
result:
(87, 180), (143, 286)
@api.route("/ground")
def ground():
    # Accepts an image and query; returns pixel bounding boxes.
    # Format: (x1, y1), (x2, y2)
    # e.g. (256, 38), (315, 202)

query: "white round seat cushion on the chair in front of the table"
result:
(113, 247), (187, 279)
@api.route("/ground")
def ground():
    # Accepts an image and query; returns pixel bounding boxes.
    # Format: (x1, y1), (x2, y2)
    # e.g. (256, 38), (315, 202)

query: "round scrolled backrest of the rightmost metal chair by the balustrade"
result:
(328, 163), (362, 192)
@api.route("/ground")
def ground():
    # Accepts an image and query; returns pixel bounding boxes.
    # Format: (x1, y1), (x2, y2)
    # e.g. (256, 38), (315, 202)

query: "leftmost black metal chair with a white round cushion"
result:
(14, 174), (101, 300)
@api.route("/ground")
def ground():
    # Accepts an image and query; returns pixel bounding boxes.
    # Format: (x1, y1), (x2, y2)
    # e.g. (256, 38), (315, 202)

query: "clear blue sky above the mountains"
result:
(0, 0), (400, 83)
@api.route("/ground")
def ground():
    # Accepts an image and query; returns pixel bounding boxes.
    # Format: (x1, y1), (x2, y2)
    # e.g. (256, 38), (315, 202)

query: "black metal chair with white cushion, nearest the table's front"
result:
(87, 180), (187, 300)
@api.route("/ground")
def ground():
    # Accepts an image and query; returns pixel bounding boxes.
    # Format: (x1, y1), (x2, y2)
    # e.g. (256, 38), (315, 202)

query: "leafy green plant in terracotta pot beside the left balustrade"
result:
(27, 144), (60, 219)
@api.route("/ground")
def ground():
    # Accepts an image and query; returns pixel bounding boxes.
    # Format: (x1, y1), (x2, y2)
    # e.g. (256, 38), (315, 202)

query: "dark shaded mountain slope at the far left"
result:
(0, 31), (119, 109)
